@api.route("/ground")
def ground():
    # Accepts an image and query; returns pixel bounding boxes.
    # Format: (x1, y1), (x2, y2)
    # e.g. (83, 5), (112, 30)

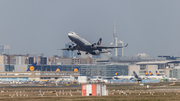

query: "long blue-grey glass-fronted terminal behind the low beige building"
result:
(0, 64), (128, 77)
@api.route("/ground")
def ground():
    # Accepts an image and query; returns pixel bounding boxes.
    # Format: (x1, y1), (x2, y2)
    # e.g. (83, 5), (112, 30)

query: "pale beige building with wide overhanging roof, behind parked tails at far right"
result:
(129, 60), (180, 79)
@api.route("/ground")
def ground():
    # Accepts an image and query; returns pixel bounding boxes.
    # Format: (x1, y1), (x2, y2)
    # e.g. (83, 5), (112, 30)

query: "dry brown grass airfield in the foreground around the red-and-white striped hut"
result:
(0, 83), (180, 101)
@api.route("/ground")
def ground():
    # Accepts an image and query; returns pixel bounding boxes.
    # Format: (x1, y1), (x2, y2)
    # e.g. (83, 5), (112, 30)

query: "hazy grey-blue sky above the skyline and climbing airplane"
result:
(0, 0), (180, 56)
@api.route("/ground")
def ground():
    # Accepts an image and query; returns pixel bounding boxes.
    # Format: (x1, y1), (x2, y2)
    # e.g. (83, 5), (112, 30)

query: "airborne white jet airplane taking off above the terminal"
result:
(61, 32), (128, 55)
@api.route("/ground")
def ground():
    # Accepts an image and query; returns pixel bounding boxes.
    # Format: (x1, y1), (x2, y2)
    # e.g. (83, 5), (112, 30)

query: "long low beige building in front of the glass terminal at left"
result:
(0, 71), (79, 82)
